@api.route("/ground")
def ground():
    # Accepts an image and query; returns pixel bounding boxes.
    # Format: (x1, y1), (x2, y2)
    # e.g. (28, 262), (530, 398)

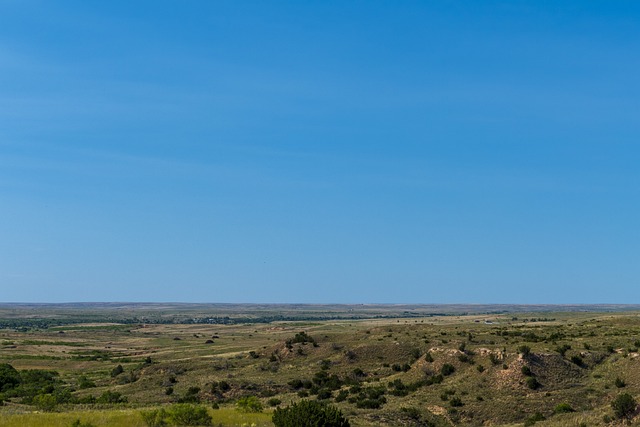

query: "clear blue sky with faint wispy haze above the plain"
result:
(0, 0), (640, 303)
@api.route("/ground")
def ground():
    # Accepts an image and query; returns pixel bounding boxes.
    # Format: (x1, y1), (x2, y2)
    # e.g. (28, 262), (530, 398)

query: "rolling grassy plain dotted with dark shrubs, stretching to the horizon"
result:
(0, 307), (640, 427)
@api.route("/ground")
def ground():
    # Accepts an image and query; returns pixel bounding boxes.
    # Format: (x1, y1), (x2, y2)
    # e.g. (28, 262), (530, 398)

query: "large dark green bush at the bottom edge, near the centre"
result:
(272, 400), (350, 427)
